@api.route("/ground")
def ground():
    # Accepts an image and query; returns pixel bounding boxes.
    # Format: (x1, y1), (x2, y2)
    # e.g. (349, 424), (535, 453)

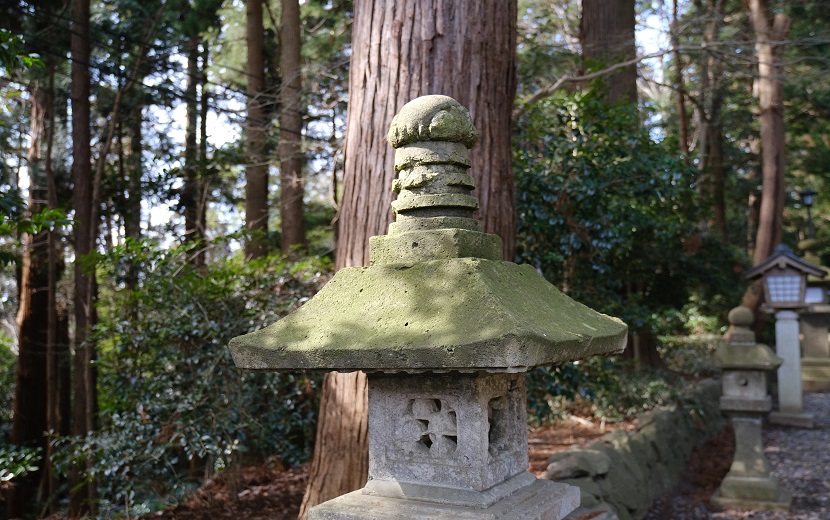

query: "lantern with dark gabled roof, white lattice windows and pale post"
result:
(745, 244), (825, 428)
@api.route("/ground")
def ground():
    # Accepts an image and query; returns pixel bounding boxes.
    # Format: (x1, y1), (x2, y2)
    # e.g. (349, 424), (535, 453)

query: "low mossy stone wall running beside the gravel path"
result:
(542, 379), (725, 520)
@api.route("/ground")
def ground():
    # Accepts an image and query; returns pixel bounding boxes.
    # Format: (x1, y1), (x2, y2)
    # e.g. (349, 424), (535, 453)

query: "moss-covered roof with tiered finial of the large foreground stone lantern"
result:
(230, 96), (627, 372)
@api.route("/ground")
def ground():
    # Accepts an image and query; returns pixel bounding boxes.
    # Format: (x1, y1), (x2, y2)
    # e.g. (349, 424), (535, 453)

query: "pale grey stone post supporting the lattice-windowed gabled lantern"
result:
(769, 310), (813, 428)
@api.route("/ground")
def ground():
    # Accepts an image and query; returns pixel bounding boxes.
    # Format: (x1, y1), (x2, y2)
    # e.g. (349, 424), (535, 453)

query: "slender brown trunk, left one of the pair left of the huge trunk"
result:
(245, 0), (268, 259)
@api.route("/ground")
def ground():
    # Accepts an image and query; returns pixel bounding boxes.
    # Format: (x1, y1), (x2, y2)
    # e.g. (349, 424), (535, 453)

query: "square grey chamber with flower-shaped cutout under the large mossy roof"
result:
(367, 374), (533, 500)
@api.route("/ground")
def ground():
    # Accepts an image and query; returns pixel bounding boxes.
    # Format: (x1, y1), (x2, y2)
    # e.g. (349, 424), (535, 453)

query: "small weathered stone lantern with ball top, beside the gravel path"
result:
(712, 307), (792, 510)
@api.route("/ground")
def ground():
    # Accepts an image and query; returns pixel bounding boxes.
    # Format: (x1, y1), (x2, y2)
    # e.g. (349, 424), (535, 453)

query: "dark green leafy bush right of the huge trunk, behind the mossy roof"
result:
(514, 91), (744, 334)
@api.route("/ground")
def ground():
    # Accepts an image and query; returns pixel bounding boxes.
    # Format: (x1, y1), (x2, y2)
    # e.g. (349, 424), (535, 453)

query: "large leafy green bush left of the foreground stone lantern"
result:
(53, 243), (329, 515)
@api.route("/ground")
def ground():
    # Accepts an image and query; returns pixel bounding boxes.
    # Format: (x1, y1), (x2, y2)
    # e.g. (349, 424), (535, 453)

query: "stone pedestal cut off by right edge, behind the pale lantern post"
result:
(801, 304), (830, 392)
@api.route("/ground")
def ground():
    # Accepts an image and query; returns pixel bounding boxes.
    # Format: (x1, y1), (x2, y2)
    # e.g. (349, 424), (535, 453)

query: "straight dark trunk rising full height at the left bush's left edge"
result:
(69, 0), (97, 517)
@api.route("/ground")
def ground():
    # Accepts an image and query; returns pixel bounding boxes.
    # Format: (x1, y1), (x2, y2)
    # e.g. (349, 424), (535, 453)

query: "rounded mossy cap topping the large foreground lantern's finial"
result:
(387, 96), (478, 148)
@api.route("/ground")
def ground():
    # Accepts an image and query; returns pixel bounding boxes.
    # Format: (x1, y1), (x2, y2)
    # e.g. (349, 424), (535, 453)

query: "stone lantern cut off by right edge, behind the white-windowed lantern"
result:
(798, 239), (830, 392)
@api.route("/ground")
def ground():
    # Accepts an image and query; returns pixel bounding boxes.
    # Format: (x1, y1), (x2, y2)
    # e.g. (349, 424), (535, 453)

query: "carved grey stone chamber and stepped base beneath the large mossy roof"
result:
(310, 373), (579, 520)
